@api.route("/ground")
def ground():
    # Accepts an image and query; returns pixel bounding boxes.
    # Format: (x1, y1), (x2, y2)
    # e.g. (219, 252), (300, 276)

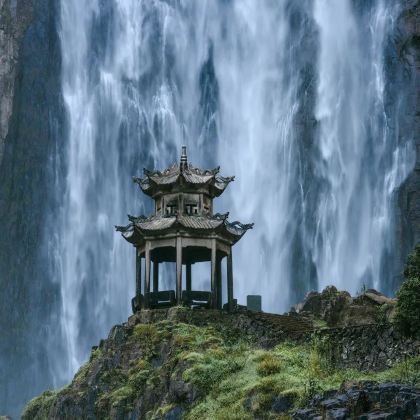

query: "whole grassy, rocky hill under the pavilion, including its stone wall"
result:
(23, 308), (420, 420)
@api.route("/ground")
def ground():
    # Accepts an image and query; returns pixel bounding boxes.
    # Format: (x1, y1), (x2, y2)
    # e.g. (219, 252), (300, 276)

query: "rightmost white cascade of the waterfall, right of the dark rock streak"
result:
(311, 0), (414, 293)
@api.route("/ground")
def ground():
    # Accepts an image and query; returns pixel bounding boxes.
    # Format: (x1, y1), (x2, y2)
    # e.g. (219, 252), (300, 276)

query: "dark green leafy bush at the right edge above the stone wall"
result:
(395, 245), (420, 337)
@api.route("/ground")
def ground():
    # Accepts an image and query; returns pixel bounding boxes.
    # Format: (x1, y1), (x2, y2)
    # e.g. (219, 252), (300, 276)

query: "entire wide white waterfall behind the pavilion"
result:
(54, 0), (412, 382)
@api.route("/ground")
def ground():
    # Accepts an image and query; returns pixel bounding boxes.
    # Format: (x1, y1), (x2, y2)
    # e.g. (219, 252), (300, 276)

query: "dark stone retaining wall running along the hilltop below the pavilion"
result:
(128, 307), (420, 370)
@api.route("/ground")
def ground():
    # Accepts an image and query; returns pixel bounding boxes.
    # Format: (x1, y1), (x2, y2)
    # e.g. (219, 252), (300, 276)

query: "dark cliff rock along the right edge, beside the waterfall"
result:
(394, 0), (420, 284)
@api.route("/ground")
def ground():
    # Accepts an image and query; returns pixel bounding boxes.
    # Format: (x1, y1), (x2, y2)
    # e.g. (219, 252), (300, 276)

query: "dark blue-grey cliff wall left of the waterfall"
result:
(0, 0), (65, 416)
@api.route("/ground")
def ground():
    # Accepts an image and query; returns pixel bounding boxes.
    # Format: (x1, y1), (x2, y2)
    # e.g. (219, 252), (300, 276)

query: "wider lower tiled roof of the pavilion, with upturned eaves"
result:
(116, 214), (253, 244)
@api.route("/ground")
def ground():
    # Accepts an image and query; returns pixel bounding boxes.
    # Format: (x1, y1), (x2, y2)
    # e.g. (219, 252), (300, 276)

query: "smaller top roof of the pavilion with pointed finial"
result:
(133, 146), (235, 197)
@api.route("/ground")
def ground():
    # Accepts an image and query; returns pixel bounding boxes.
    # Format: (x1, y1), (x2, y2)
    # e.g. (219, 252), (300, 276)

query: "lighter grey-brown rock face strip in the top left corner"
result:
(0, 0), (33, 164)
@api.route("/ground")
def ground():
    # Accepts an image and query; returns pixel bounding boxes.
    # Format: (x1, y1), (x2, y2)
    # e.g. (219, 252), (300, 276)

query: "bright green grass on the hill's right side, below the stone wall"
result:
(185, 339), (420, 419)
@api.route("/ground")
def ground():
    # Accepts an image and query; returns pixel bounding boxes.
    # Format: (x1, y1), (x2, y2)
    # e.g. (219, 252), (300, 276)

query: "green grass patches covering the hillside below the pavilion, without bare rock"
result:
(24, 321), (419, 419)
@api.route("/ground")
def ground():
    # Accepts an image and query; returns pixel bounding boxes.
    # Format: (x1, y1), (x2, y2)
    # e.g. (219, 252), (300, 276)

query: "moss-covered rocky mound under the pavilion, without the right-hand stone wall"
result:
(23, 308), (419, 420)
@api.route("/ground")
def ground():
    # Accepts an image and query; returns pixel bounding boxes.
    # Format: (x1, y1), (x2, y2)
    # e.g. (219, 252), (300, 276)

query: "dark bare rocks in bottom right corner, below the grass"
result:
(292, 383), (420, 420)
